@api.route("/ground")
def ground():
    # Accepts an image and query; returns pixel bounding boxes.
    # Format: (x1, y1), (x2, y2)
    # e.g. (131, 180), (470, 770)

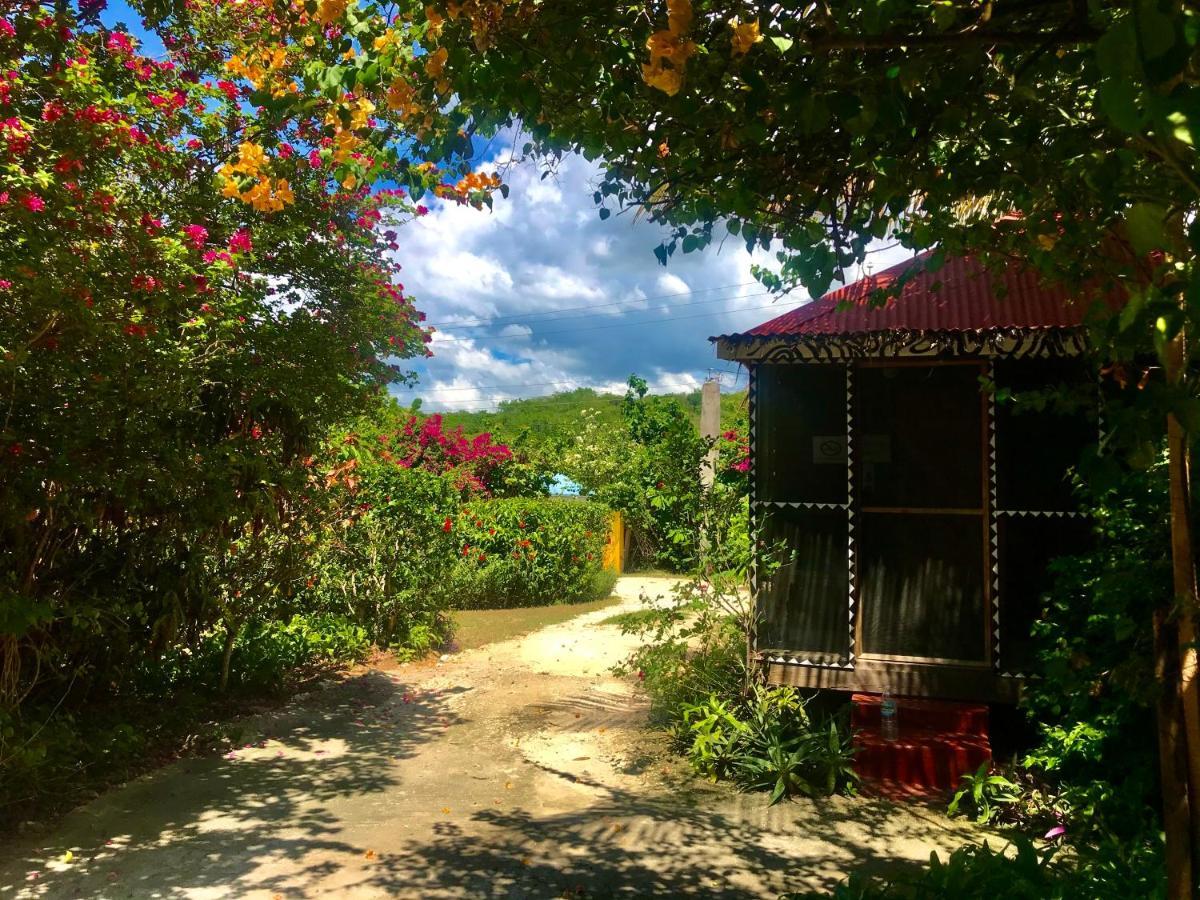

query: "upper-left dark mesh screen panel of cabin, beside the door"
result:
(755, 365), (846, 503)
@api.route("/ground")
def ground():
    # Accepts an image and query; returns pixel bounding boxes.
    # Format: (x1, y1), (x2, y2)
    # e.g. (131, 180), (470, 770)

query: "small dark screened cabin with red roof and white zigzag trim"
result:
(712, 254), (1098, 702)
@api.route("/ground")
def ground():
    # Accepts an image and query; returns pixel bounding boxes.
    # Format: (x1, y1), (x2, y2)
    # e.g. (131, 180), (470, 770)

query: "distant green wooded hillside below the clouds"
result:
(417, 388), (746, 434)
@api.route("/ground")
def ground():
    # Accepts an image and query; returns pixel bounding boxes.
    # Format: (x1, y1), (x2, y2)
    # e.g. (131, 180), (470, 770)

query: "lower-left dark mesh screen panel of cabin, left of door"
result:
(758, 509), (850, 659)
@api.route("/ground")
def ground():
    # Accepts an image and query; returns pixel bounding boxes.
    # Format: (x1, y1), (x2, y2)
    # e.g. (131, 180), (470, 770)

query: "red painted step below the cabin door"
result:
(851, 694), (991, 794)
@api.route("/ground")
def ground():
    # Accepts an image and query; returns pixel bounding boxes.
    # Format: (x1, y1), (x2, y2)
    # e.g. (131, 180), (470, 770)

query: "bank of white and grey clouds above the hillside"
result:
(396, 148), (902, 410)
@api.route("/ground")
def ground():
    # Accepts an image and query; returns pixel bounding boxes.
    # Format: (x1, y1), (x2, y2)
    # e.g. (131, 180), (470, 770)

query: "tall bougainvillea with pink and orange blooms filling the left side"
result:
(0, 0), (508, 820)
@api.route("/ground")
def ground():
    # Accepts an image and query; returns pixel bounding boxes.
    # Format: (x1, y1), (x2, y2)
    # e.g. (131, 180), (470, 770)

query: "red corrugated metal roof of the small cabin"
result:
(714, 252), (1088, 340)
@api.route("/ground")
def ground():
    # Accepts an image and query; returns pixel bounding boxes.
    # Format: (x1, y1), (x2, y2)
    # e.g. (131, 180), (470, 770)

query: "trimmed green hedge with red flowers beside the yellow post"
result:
(450, 497), (614, 610)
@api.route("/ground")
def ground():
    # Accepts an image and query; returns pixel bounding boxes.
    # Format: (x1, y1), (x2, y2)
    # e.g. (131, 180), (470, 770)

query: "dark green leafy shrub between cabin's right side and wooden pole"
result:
(1022, 458), (1171, 840)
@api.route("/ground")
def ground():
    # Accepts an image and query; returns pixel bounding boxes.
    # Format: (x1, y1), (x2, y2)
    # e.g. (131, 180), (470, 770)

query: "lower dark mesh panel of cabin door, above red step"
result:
(857, 512), (986, 661)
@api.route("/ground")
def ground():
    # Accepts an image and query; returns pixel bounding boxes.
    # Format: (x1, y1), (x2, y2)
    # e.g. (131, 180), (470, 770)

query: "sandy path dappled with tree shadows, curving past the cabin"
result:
(0, 577), (984, 900)
